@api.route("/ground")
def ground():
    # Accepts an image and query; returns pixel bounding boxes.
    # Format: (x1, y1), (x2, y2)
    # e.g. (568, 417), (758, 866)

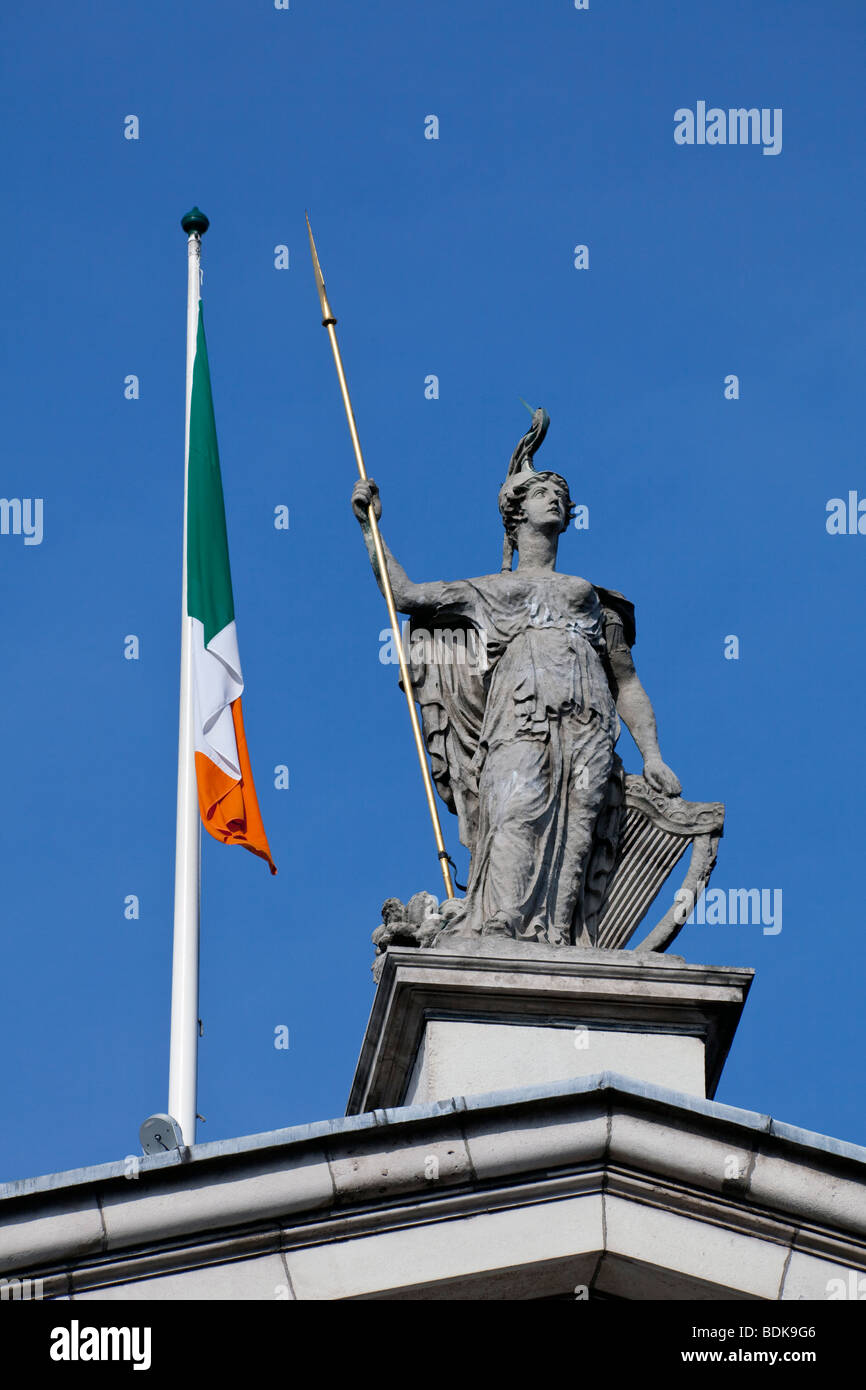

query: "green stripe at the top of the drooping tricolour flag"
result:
(186, 303), (235, 646)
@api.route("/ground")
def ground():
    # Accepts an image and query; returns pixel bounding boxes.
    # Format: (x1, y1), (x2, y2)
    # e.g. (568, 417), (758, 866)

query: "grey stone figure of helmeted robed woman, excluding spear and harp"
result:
(352, 410), (681, 945)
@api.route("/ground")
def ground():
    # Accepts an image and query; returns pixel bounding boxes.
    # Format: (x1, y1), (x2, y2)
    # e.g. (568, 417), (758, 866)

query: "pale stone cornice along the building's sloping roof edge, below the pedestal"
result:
(0, 1073), (866, 1298)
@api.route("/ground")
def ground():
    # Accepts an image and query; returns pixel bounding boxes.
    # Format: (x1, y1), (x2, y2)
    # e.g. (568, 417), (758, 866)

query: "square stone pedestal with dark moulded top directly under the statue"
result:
(348, 937), (753, 1115)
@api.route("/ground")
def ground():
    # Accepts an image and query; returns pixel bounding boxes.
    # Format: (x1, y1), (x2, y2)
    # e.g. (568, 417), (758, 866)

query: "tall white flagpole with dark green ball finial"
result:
(168, 207), (209, 1144)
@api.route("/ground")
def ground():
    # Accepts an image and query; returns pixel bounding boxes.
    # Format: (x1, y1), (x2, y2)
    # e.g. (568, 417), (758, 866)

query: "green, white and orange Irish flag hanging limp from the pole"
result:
(186, 303), (277, 873)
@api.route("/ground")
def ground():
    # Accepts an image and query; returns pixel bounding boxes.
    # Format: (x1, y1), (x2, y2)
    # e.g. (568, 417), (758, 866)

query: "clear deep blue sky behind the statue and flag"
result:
(0, 0), (866, 1179)
